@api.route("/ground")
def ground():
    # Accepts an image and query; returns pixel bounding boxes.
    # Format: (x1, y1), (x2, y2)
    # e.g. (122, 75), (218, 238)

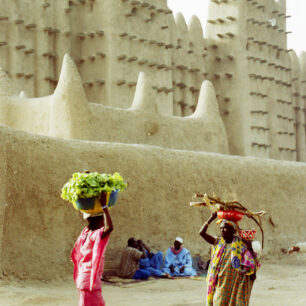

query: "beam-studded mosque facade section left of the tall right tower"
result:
(0, 0), (207, 116)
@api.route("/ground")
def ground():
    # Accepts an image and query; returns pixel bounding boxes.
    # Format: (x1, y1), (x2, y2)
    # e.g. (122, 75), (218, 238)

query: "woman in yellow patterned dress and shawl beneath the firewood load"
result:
(199, 212), (259, 306)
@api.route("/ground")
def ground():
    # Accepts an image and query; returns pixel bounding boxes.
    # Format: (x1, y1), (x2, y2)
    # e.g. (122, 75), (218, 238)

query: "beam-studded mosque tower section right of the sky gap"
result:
(206, 0), (306, 161)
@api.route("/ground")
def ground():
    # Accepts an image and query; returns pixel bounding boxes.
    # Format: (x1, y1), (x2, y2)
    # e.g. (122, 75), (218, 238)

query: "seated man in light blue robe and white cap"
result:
(163, 237), (197, 276)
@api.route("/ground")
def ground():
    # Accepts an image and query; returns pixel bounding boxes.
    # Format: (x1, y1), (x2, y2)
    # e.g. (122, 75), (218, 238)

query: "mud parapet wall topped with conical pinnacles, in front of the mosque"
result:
(0, 55), (228, 154)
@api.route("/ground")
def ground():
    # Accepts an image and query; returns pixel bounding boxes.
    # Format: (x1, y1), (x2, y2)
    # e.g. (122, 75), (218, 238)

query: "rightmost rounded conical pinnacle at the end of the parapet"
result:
(192, 80), (221, 120)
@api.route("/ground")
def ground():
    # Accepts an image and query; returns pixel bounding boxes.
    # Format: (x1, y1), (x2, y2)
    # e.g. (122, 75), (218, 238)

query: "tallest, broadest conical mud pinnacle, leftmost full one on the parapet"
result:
(50, 54), (91, 139)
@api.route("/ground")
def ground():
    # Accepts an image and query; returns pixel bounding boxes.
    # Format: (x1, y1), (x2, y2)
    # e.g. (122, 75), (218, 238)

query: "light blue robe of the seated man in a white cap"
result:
(163, 248), (197, 276)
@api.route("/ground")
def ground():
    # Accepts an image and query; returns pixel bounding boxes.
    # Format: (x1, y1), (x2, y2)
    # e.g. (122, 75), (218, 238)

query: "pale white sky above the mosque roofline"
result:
(168, 0), (306, 53)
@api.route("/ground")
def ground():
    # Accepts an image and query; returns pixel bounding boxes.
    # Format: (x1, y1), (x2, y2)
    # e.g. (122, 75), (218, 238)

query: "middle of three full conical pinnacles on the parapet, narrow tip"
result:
(130, 72), (158, 113)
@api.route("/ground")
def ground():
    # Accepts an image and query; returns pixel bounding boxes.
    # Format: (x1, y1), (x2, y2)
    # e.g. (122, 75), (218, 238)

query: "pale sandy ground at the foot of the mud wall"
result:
(0, 261), (306, 306)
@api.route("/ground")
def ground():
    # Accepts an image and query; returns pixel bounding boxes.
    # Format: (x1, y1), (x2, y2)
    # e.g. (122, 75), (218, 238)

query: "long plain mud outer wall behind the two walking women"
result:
(0, 126), (306, 280)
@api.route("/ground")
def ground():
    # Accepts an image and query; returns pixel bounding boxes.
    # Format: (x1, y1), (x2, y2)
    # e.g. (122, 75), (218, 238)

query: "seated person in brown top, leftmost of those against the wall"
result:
(118, 238), (150, 279)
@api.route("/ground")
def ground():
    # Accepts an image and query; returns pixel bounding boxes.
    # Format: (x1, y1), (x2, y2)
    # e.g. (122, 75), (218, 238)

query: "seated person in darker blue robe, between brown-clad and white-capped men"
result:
(137, 240), (168, 277)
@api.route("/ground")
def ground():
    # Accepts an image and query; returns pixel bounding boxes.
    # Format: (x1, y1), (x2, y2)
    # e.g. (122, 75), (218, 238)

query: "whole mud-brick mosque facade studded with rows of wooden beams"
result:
(0, 0), (306, 161)
